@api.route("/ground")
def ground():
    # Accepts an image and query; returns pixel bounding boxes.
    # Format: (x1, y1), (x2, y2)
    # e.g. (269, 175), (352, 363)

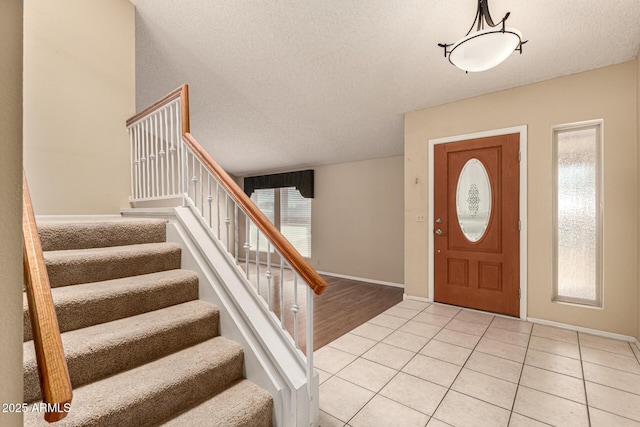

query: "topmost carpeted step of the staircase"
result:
(38, 218), (167, 251)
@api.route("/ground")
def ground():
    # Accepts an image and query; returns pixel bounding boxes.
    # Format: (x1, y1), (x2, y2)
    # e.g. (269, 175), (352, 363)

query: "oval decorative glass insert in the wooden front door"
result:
(456, 158), (491, 242)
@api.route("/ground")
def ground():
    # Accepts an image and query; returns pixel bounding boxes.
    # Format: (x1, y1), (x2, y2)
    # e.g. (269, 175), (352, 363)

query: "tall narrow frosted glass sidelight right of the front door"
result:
(554, 125), (602, 305)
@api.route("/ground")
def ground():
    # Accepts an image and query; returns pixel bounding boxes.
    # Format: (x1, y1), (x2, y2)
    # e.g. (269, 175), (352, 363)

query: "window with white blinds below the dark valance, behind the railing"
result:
(249, 187), (311, 258)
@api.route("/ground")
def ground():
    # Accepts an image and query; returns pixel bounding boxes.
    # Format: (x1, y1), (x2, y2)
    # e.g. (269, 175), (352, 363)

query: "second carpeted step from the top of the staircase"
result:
(44, 243), (181, 288)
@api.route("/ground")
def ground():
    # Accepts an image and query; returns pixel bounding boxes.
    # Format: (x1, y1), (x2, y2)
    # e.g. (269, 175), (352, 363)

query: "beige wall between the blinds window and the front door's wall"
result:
(311, 156), (404, 284)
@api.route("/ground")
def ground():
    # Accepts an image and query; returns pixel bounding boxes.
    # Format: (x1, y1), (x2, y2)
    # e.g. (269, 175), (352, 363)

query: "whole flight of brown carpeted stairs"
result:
(24, 219), (273, 427)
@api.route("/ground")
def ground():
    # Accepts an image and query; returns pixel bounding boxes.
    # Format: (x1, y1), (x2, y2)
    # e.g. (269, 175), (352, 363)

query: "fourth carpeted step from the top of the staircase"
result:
(23, 300), (219, 402)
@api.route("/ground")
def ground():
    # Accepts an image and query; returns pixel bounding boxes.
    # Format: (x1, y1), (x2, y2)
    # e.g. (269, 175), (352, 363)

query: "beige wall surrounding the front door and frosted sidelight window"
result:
(405, 61), (638, 336)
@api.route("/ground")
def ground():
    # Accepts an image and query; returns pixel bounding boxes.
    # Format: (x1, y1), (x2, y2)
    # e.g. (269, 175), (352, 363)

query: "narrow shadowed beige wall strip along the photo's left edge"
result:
(0, 0), (23, 427)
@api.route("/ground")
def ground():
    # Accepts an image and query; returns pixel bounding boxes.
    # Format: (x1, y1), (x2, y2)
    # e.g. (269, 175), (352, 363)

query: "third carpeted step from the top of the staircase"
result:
(23, 270), (198, 341)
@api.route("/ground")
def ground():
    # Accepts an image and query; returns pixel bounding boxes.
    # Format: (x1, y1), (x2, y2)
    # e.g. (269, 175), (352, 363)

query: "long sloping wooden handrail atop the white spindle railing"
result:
(182, 132), (327, 295)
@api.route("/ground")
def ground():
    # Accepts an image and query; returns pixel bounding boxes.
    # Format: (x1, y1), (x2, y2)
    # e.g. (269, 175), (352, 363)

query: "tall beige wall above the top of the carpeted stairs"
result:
(24, 0), (135, 214)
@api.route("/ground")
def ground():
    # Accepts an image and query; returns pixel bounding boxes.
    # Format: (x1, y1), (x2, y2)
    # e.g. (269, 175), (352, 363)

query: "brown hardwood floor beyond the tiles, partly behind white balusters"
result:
(249, 272), (404, 352)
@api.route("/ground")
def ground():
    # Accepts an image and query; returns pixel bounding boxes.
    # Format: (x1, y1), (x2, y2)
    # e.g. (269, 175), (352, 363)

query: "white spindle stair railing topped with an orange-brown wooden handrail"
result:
(127, 85), (326, 427)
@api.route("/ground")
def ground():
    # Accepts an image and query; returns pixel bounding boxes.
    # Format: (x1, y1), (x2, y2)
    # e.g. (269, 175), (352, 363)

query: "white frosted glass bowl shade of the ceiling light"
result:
(449, 28), (522, 72)
